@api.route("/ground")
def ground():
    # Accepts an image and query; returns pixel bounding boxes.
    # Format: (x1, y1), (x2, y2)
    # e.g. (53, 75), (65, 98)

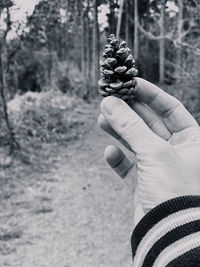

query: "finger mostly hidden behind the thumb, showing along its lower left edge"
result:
(98, 114), (132, 151)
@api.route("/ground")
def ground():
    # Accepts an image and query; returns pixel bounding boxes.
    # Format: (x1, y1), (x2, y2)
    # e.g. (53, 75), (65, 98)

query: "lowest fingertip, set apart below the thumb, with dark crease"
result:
(104, 145), (133, 178)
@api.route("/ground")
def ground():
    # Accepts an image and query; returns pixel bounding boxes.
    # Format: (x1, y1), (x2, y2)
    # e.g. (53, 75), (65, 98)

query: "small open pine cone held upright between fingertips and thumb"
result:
(98, 34), (138, 103)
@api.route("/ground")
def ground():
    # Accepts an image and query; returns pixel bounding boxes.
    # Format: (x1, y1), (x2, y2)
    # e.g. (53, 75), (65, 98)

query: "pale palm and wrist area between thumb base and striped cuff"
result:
(137, 127), (200, 215)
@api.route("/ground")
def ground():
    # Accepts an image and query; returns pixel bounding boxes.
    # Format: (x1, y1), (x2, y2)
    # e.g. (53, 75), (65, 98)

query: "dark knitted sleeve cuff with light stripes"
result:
(131, 196), (200, 267)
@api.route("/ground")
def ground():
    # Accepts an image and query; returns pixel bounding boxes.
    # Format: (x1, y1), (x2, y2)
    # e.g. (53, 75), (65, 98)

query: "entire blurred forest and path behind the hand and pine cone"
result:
(0, 0), (200, 267)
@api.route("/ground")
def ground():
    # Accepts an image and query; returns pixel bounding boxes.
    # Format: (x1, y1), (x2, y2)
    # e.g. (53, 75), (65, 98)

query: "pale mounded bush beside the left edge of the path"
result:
(8, 91), (91, 145)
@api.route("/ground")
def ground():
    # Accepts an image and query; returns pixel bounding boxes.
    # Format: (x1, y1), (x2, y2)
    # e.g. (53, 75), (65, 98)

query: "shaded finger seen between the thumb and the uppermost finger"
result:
(131, 100), (171, 140)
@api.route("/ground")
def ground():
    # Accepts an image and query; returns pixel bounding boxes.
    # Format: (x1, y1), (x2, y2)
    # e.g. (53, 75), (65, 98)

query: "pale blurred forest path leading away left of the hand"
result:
(0, 110), (135, 267)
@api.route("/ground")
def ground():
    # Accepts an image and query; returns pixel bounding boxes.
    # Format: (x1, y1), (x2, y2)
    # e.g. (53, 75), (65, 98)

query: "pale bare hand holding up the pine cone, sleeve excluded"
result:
(98, 78), (200, 224)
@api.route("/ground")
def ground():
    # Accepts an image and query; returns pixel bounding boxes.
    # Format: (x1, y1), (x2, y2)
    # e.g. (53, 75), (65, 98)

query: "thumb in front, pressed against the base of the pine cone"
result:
(101, 96), (166, 154)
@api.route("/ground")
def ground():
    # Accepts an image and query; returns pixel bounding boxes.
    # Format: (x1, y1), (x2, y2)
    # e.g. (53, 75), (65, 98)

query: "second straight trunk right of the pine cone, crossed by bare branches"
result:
(159, 0), (165, 83)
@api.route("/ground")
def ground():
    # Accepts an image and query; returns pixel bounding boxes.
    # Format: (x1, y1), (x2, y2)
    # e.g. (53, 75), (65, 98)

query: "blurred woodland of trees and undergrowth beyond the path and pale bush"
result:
(0, 0), (200, 158)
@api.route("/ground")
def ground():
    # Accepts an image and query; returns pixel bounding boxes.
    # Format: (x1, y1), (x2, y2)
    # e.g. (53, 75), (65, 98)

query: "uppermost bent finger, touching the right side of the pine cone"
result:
(135, 78), (198, 133)
